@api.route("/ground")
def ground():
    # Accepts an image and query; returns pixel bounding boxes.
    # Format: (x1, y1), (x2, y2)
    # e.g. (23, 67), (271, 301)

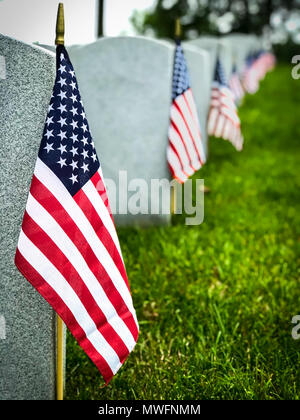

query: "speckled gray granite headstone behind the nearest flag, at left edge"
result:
(0, 35), (61, 400)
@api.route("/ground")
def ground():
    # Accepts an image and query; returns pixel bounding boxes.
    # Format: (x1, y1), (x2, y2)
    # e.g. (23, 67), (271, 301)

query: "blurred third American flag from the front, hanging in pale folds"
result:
(207, 59), (243, 150)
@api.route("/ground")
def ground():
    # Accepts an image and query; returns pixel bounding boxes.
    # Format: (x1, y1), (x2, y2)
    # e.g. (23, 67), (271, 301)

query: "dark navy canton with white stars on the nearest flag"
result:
(39, 46), (100, 195)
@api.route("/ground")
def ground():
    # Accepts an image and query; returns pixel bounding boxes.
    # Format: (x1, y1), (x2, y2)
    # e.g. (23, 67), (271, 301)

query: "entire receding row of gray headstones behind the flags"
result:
(0, 31), (268, 399)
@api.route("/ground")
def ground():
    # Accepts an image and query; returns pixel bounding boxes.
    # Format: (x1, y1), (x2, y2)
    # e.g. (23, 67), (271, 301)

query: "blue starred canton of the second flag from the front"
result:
(172, 41), (190, 100)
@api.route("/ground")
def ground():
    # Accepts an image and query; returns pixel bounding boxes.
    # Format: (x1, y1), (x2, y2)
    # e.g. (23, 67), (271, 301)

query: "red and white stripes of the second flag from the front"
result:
(167, 88), (206, 183)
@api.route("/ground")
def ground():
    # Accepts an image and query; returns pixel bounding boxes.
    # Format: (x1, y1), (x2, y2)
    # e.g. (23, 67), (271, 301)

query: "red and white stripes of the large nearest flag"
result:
(15, 158), (138, 382)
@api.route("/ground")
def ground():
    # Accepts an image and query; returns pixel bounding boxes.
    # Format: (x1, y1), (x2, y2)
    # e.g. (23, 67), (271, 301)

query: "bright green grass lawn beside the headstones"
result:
(65, 65), (300, 399)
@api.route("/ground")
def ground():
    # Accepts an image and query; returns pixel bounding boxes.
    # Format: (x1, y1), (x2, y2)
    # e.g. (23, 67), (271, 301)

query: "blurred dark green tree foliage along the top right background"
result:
(131, 0), (300, 61)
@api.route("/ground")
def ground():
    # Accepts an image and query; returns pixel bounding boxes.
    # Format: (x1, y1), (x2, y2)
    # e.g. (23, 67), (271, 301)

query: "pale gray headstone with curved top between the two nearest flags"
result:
(68, 37), (174, 225)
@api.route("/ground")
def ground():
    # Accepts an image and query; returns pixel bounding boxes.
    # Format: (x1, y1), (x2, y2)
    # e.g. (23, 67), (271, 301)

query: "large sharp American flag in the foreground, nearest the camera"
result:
(15, 46), (138, 383)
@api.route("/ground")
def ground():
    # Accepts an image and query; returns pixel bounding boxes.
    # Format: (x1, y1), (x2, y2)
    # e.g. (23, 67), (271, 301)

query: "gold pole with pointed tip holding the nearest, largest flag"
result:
(55, 3), (65, 401)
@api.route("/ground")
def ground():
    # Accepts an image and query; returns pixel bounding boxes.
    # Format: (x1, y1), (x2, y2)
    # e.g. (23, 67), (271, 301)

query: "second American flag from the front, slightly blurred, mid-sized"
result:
(167, 41), (206, 183)
